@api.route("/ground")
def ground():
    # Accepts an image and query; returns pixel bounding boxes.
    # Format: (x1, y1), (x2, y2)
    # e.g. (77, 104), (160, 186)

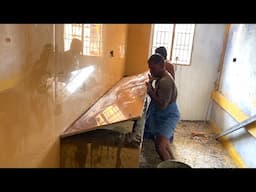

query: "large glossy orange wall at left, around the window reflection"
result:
(0, 24), (127, 167)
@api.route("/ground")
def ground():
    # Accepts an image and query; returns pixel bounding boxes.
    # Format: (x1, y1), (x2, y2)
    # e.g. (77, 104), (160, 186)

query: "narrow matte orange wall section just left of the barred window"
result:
(125, 24), (151, 75)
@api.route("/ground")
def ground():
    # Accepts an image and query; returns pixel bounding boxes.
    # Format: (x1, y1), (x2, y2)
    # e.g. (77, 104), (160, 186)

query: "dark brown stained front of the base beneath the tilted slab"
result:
(61, 130), (141, 168)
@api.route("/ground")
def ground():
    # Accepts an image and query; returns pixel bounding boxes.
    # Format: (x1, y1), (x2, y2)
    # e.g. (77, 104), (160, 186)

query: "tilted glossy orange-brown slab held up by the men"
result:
(61, 73), (148, 138)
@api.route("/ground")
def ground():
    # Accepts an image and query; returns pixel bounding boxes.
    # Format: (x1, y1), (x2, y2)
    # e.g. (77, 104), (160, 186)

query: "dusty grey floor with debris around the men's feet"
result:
(140, 121), (236, 168)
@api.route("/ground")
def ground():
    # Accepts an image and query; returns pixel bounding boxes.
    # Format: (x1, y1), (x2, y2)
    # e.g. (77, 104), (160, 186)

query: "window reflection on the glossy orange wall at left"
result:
(64, 24), (102, 56)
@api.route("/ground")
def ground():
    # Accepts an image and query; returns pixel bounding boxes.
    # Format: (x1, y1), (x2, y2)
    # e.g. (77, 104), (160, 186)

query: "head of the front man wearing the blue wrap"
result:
(148, 53), (165, 77)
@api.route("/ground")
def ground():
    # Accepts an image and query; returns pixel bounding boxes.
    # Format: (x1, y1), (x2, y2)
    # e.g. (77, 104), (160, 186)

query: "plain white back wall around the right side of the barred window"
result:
(175, 24), (225, 120)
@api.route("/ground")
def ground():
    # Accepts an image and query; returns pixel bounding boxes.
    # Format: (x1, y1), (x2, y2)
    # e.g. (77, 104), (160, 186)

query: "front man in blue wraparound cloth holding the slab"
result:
(144, 54), (180, 161)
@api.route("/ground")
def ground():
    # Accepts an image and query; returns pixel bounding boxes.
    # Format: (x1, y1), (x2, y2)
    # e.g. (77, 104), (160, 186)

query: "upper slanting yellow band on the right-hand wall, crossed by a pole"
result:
(212, 91), (256, 137)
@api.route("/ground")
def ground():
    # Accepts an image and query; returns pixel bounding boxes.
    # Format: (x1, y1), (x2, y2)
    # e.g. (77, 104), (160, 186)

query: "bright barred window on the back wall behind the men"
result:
(152, 24), (195, 65)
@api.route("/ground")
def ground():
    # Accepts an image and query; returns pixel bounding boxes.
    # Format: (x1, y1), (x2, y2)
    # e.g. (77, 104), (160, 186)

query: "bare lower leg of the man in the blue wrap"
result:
(155, 135), (173, 161)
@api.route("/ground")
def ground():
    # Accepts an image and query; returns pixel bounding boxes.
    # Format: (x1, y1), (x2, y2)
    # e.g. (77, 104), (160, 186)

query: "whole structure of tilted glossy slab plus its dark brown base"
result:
(60, 73), (147, 168)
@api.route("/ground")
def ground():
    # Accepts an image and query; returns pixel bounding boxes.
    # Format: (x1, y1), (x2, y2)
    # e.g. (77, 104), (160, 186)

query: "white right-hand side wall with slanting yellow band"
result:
(211, 24), (256, 168)
